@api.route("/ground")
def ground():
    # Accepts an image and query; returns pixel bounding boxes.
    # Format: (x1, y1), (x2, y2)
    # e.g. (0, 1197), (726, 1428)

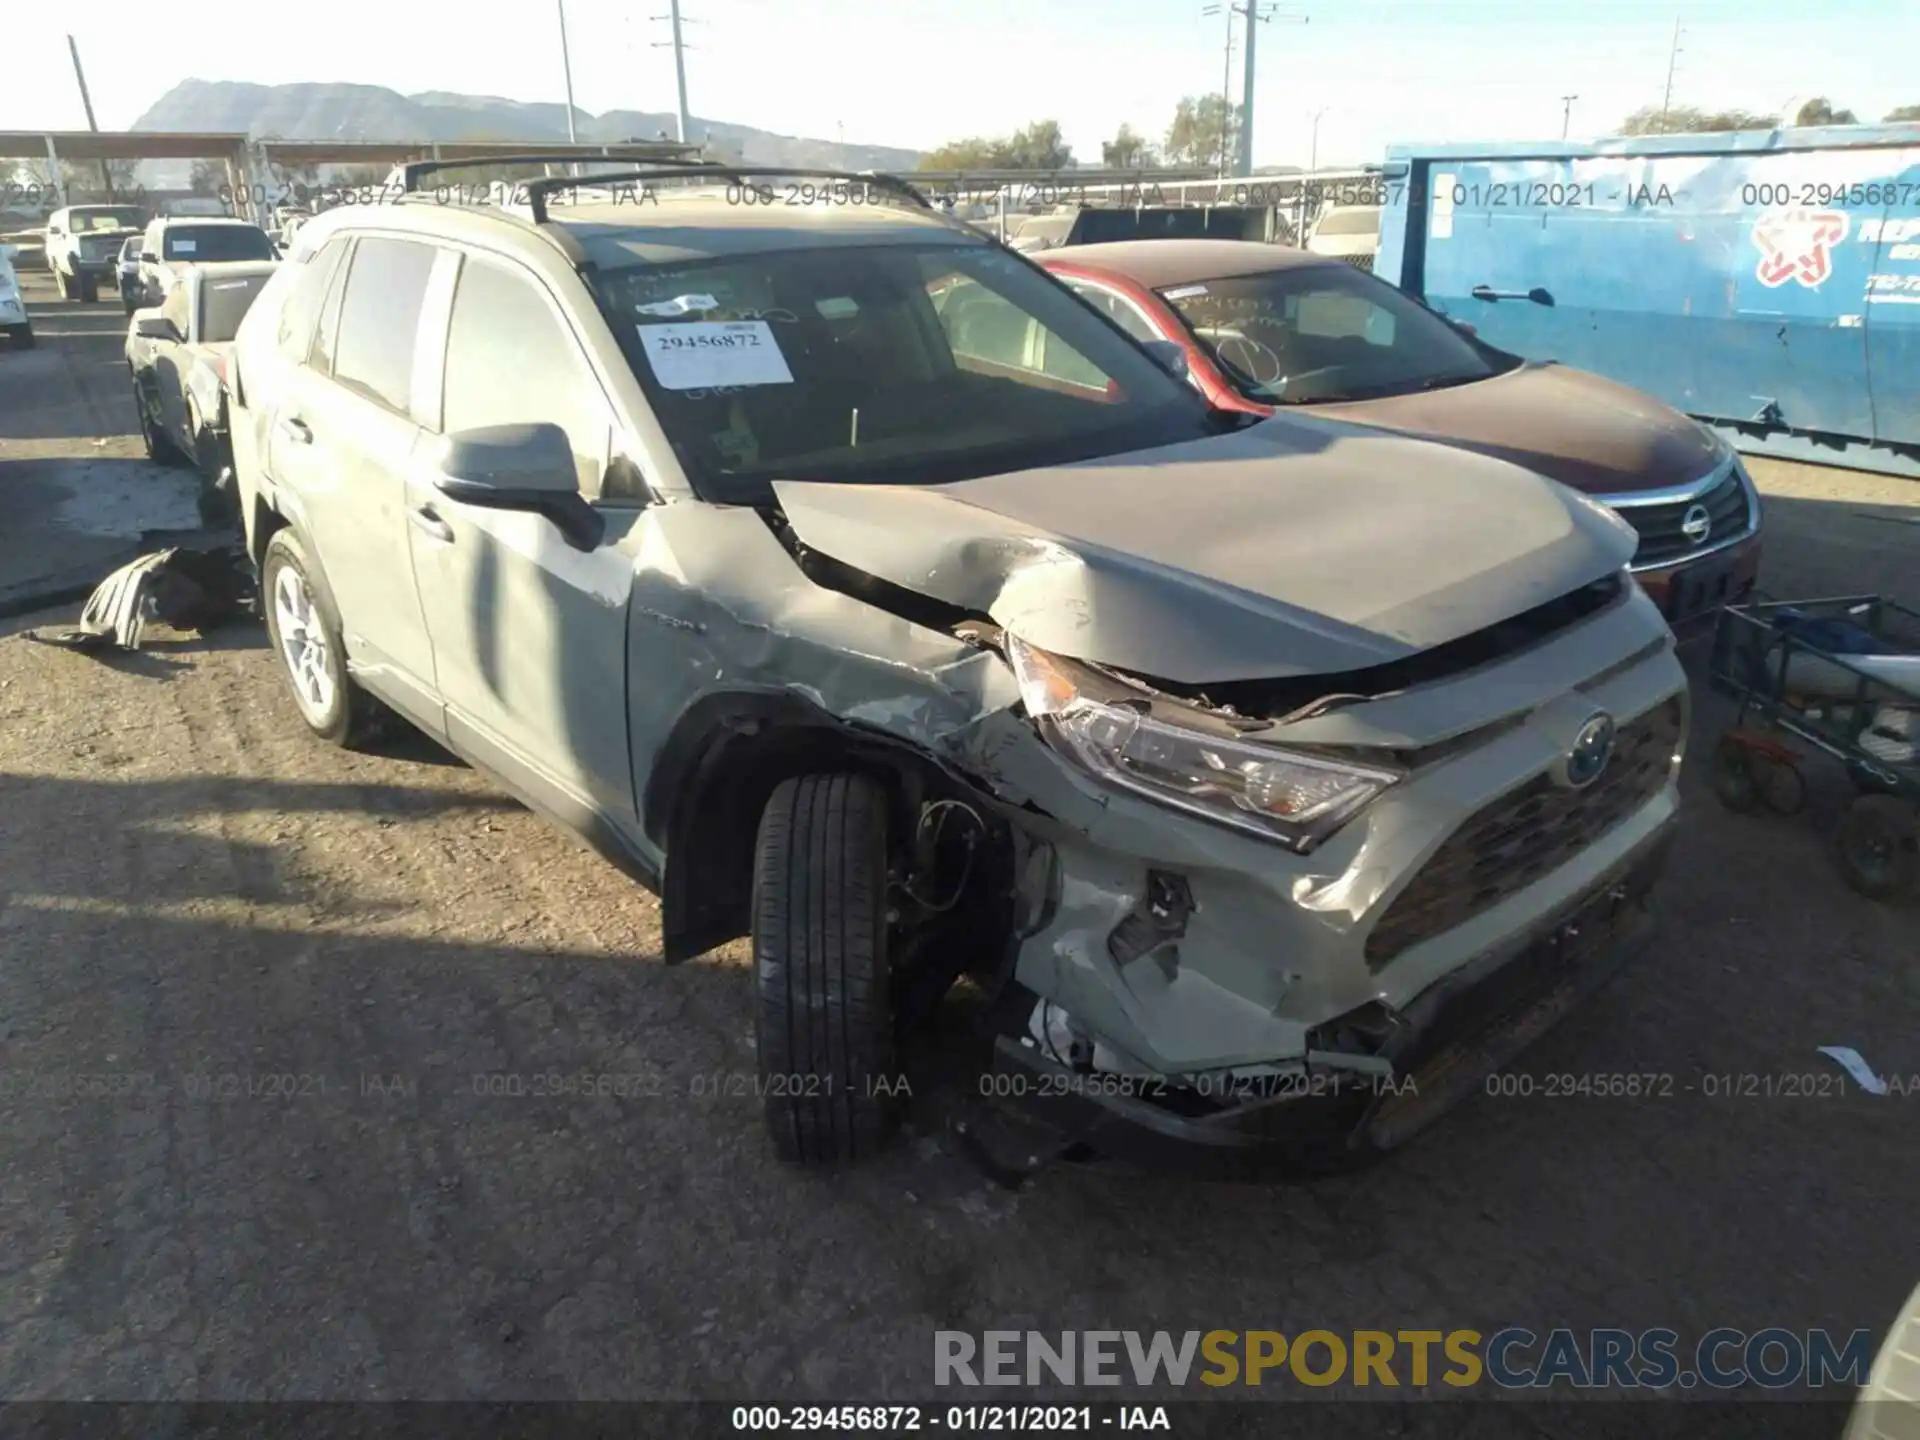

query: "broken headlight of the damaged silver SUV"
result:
(1006, 636), (1400, 854)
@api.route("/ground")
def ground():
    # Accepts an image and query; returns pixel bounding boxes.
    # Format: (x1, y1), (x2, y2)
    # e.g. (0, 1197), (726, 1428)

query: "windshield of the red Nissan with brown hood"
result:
(1162, 265), (1519, 405)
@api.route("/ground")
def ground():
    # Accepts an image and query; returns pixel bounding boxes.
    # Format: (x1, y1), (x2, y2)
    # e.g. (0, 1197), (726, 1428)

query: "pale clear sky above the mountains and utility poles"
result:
(0, 0), (1920, 165)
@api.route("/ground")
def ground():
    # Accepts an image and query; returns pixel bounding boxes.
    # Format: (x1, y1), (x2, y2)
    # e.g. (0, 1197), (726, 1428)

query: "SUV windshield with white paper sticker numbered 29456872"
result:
(595, 244), (1221, 503)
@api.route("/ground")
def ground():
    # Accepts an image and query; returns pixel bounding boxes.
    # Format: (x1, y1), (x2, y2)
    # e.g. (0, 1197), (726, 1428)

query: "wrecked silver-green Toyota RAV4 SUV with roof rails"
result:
(232, 163), (1688, 1169)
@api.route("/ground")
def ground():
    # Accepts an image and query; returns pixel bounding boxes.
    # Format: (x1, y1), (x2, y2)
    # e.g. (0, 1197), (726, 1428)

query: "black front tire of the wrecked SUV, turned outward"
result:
(753, 774), (900, 1165)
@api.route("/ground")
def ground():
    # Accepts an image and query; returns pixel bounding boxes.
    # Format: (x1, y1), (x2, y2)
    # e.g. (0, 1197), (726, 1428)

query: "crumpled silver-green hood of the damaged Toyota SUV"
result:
(774, 417), (1636, 684)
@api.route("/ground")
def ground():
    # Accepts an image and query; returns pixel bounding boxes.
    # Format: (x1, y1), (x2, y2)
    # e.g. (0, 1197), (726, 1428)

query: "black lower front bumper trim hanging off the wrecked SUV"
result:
(983, 820), (1674, 1179)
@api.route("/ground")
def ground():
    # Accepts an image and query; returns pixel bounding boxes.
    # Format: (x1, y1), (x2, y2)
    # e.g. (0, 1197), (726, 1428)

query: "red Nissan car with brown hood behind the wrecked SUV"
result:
(1041, 240), (1761, 624)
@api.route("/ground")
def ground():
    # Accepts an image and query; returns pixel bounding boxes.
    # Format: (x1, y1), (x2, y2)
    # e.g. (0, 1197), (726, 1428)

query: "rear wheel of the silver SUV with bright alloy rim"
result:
(259, 530), (388, 751)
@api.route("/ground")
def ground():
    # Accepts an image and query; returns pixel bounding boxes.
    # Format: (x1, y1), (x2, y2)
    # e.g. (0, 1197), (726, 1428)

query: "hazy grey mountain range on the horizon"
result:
(132, 81), (920, 171)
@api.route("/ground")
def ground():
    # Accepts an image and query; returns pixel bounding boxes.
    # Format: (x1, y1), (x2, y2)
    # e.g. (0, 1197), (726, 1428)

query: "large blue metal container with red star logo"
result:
(1375, 125), (1920, 474)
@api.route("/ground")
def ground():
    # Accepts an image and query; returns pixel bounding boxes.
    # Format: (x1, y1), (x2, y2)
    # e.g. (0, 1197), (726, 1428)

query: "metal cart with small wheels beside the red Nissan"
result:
(1711, 595), (1920, 900)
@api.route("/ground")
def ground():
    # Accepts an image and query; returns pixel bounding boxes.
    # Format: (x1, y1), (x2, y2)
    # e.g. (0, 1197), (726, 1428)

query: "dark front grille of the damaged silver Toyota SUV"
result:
(1367, 699), (1682, 970)
